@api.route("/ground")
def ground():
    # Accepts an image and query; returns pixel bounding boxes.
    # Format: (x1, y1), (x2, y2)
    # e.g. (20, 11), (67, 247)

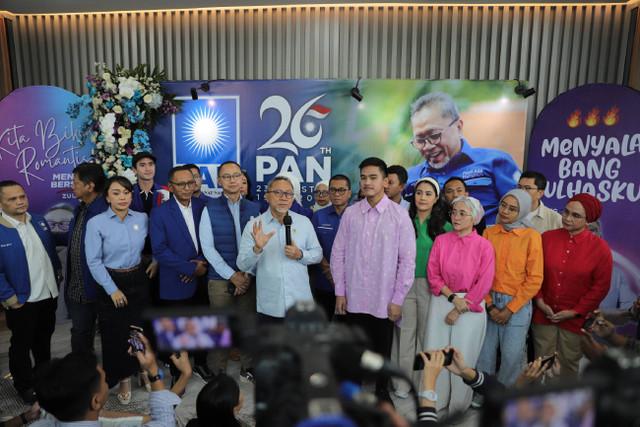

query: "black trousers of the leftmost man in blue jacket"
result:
(6, 298), (58, 394)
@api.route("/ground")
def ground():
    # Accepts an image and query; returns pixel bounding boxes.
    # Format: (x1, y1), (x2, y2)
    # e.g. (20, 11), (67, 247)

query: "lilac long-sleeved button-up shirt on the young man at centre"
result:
(331, 196), (416, 319)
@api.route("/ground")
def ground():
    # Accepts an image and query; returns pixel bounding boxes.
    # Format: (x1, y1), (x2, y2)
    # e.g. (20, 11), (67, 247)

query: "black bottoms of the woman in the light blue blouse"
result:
(98, 267), (149, 387)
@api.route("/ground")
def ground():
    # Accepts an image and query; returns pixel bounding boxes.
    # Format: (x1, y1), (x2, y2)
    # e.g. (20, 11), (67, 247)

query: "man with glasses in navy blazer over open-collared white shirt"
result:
(149, 166), (214, 382)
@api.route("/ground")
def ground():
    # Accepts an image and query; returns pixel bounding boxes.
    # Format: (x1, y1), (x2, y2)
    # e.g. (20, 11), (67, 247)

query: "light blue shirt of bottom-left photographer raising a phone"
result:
(31, 390), (182, 427)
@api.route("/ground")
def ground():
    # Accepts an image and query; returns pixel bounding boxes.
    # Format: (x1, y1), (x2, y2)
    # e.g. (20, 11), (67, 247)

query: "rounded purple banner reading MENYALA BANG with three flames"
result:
(528, 84), (640, 295)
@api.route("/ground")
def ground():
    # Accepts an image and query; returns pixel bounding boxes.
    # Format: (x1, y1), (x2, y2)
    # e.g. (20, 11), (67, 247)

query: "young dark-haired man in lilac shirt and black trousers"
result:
(331, 157), (416, 401)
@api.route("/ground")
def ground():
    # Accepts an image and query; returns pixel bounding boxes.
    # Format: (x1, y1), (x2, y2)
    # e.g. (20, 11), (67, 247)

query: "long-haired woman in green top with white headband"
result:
(391, 178), (453, 398)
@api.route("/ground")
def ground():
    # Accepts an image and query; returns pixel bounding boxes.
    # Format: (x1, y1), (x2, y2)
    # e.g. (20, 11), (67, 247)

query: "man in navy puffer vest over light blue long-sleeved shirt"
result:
(200, 161), (260, 382)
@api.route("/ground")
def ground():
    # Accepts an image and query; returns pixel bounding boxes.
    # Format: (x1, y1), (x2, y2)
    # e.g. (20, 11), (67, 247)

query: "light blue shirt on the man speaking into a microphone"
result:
(236, 209), (322, 317)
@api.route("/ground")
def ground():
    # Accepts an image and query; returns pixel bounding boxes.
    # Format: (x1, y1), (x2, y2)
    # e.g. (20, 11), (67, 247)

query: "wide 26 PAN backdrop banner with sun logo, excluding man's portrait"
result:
(151, 80), (526, 217)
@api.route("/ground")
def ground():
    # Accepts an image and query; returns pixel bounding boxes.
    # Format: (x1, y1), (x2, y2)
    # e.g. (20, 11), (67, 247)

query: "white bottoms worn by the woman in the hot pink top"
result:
(425, 293), (487, 415)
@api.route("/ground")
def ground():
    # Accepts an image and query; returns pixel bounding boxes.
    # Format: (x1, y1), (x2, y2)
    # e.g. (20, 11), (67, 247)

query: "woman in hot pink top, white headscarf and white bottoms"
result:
(425, 196), (495, 414)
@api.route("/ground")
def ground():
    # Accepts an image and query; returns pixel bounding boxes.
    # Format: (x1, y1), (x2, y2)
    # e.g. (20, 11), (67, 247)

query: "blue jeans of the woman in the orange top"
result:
(477, 291), (533, 387)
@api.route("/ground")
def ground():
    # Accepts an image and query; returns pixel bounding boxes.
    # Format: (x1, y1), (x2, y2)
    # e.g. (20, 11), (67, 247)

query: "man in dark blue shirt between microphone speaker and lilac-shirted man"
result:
(311, 175), (351, 320)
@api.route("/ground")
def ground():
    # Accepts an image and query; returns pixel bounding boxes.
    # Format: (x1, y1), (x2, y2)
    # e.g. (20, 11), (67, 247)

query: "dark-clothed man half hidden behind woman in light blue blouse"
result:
(64, 163), (107, 351)
